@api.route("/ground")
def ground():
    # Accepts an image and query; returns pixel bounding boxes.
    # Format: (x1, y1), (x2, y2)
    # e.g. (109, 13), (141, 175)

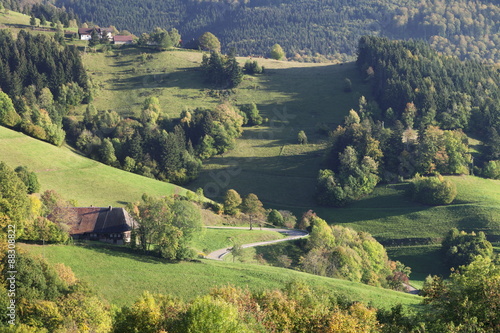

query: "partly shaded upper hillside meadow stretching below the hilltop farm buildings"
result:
(74, 47), (370, 205)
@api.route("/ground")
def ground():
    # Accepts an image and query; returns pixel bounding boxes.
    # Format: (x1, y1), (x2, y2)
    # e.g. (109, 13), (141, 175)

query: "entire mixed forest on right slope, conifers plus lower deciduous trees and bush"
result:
(316, 36), (500, 207)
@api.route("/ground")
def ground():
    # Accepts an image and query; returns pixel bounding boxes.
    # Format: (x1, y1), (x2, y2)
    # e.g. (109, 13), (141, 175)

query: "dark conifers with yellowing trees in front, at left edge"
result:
(0, 29), (91, 146)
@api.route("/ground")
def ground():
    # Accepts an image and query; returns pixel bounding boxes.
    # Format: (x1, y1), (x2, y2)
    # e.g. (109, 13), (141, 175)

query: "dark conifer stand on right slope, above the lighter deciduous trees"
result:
(357, 37), (500, 174)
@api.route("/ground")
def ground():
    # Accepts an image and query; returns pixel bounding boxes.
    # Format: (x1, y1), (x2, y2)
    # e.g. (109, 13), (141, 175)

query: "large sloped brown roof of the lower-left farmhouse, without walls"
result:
(70, 207), (137, 235)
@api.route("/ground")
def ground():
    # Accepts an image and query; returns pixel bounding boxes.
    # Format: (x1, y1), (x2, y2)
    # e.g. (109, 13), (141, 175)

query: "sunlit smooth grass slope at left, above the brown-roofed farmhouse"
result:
(0, 127), (186, 207)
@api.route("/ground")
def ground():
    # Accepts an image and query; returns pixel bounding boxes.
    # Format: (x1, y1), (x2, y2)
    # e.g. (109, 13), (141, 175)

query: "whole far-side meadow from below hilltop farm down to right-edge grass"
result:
(75, 47), (500, 243)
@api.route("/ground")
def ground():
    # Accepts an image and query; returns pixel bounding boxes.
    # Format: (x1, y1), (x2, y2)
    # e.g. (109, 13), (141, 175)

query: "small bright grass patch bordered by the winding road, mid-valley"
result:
(192, 229), (285, 254)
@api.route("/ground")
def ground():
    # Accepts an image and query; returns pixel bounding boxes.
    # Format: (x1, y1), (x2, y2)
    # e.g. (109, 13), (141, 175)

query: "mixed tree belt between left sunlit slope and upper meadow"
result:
(64, 97), (262, 184)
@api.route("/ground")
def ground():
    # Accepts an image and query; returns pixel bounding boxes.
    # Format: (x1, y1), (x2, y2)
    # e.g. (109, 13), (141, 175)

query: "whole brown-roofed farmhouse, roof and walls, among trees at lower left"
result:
(69, 206), (138, 244)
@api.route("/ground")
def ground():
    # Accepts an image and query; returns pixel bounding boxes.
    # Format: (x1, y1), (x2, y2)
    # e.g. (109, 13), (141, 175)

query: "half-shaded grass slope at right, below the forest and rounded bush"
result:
(290, 176), (500, 243)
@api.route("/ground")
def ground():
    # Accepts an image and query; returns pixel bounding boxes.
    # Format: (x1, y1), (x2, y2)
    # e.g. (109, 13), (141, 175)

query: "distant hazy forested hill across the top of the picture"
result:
(56, 0), (500, 62)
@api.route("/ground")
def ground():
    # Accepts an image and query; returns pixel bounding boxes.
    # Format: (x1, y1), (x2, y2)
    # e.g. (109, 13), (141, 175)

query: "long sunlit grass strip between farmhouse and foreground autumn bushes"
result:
(22, 244), (421, 308)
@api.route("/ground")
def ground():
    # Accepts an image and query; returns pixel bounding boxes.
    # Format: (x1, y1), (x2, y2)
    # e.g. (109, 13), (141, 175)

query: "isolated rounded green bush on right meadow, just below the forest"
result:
(409, 175), (457, 206)
